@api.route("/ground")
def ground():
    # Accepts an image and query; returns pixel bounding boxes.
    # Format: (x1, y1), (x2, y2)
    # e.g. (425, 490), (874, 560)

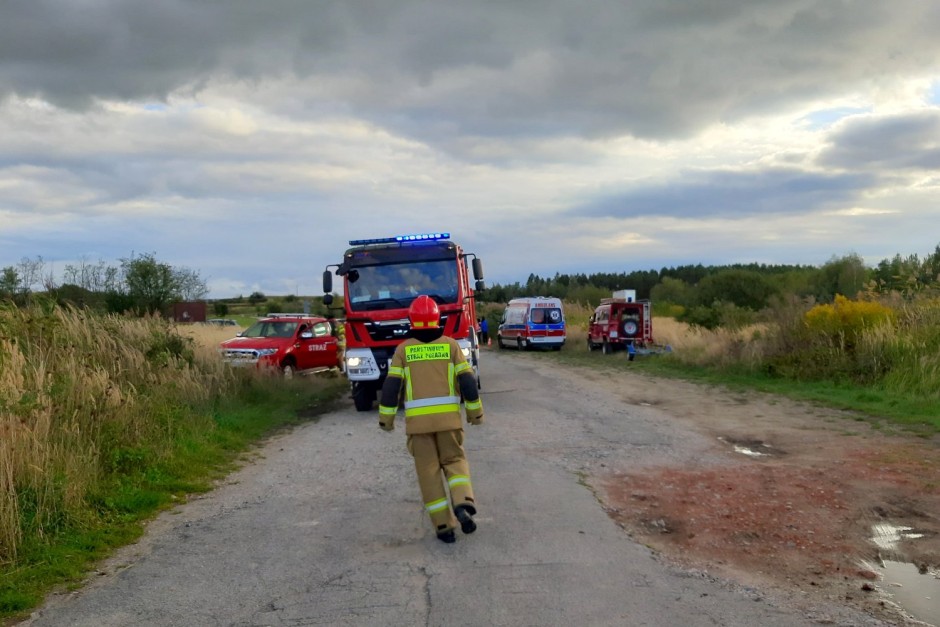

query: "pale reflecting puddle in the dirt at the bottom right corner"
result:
(865, 523), (940, 626)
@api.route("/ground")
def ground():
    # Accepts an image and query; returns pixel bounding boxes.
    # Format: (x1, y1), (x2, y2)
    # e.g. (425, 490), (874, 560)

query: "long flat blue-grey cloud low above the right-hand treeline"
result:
(572, 169), (876, 219)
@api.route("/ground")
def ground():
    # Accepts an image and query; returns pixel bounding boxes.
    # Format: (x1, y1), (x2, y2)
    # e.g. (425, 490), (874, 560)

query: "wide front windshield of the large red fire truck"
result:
(346, 259), (458, 311)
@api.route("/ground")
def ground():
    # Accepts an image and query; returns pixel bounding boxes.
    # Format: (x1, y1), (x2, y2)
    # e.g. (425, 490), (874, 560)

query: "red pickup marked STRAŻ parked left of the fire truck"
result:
(219, 314), (340, 378)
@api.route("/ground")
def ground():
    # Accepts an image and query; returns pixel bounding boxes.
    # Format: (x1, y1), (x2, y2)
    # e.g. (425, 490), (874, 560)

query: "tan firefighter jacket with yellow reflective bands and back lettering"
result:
(379, 336), (483, 434)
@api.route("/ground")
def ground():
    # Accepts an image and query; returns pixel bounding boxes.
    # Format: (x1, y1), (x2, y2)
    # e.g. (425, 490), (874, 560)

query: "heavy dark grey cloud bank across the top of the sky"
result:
(0, 0), (940, 138)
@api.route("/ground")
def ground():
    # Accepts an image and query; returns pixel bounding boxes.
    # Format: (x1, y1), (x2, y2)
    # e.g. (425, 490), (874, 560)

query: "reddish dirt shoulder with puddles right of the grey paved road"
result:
(572, 356), (940, 625)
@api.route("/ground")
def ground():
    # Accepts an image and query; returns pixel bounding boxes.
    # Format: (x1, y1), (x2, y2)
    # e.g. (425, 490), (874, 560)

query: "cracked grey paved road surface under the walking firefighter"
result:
(24, 351), (882, 627)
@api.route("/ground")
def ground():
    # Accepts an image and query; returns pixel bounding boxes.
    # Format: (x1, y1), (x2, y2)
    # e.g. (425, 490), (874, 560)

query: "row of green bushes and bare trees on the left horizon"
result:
(0, 253), (209, 314)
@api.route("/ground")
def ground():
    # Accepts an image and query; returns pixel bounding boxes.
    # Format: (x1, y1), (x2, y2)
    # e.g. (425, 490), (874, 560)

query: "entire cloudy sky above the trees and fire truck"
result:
(0, 0), (940, 297)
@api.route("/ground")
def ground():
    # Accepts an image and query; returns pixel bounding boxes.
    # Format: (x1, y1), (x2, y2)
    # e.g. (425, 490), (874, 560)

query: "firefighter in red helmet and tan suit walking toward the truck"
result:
(379, 295), (483, 544)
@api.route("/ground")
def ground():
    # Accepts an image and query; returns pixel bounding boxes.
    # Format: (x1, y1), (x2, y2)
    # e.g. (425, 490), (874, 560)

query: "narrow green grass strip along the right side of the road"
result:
(510, 346), (940, 437)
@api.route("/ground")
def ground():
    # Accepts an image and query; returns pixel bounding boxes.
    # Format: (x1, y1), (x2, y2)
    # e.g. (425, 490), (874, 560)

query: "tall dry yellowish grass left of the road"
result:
(0, 304), (236, 564)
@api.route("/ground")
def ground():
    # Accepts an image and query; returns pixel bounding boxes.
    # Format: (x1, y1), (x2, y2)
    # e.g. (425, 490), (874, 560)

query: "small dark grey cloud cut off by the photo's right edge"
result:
(819, 110), (940, 171)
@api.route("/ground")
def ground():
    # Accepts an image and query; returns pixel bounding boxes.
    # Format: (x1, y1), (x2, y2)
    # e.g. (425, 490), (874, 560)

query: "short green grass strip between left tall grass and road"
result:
(0, 378), (348, 624)
